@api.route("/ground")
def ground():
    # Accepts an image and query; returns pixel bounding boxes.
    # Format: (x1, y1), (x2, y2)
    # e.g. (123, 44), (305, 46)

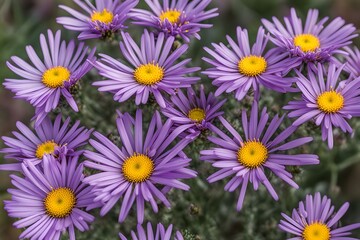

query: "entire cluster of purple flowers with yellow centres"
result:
(0, 0), (360, 240)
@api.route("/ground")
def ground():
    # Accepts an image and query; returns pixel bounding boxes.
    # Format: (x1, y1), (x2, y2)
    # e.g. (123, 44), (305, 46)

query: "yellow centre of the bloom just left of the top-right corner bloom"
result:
(238, 55), (267, 77)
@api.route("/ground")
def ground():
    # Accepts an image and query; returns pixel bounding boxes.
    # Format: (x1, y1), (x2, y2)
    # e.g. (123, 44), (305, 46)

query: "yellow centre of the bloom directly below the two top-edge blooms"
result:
(134, 63), (164, 85)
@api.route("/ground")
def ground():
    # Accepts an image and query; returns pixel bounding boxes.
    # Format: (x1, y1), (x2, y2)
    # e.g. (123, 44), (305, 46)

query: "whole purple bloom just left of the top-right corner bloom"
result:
(203, 27), (297, 101)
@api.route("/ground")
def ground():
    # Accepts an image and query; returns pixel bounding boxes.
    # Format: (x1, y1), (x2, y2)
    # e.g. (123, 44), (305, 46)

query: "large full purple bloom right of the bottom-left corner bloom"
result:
(84, 110), (196, 223)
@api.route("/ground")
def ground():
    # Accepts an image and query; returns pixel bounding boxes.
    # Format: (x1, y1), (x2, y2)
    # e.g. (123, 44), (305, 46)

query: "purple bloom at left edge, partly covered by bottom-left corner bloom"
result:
(0, 115), (92, 171)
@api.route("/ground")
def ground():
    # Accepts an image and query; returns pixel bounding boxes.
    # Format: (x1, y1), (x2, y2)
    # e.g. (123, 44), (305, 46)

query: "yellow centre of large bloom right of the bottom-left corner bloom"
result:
(122, 153), (154, 183)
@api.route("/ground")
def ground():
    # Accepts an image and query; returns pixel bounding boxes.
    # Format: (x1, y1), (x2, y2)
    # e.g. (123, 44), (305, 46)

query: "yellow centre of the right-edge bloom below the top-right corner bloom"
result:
(316, 90), (344, 113)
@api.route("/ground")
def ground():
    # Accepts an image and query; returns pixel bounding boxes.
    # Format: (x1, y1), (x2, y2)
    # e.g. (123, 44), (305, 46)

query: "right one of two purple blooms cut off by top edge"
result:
(130, 0), (219, 42)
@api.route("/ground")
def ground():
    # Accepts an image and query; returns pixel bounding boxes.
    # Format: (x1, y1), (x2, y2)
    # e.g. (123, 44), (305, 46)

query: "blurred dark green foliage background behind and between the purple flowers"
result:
(0, 0), (360, 240)
